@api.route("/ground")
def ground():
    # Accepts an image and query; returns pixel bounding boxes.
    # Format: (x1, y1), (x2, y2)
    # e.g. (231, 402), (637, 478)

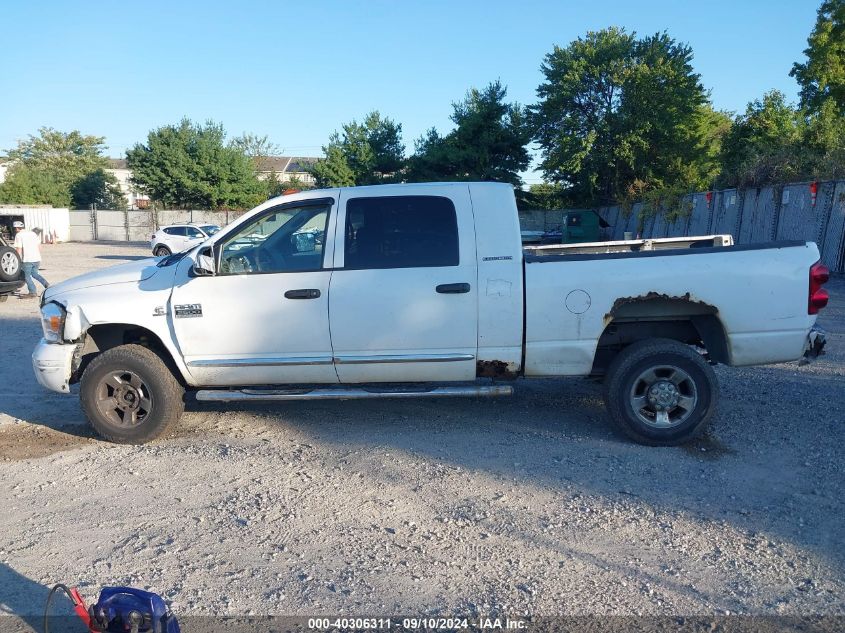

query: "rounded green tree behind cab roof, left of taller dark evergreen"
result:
(312, 111), (405, 187)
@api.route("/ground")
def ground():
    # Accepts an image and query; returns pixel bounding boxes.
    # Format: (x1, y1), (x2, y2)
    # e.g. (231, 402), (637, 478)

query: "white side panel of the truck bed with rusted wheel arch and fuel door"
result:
(525, 243), (818, 376)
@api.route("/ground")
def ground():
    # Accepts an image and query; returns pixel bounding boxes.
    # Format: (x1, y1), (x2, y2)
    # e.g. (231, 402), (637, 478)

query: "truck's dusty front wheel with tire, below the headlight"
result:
(79, 345), (185, 444)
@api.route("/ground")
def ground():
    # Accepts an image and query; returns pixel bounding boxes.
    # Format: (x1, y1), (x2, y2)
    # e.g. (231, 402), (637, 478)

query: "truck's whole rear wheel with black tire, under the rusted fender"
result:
(604, 338), (719, 446)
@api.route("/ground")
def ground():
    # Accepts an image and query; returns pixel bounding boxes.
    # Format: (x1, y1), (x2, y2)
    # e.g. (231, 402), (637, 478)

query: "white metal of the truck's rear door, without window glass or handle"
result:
(329, 184), (478, 383)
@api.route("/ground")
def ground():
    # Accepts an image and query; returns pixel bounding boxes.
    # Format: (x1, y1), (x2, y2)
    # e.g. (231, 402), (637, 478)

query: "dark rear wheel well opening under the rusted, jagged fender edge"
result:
(591, 295), (730, 376)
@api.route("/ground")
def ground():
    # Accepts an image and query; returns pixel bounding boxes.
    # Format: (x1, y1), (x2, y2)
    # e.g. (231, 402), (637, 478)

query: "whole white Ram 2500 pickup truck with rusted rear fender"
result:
(28, 183), (828, 445)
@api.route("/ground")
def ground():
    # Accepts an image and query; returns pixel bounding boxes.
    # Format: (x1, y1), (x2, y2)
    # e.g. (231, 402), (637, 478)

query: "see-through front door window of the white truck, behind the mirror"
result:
(220, 204), (329, 275)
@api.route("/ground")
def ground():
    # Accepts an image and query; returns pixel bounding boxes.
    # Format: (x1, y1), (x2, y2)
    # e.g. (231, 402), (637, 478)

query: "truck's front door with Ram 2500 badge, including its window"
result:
(169, 197), (337, 385)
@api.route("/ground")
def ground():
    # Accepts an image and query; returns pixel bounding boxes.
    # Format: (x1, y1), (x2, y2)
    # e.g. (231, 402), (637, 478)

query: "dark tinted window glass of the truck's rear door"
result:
(344, 196), (459, 269)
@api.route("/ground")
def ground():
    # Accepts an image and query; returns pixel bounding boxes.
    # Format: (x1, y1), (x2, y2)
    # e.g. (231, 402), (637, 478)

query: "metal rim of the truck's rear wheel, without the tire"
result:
(630, 365), (698, 429)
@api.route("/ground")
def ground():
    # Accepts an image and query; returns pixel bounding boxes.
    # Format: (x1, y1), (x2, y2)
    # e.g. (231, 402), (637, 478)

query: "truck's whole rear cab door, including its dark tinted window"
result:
(329, 185), (478, 383)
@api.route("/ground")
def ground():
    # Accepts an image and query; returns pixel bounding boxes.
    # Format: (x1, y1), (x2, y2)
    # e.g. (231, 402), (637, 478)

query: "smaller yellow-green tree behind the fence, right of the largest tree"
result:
(718, 90), (808, 187)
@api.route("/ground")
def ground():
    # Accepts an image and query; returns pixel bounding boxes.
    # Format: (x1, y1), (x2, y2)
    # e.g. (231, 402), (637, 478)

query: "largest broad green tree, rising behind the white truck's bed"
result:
(531, 27), (709, 205)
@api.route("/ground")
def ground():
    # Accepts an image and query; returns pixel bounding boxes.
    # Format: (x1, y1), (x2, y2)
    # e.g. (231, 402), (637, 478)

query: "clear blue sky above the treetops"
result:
(0, 0), (820, 183)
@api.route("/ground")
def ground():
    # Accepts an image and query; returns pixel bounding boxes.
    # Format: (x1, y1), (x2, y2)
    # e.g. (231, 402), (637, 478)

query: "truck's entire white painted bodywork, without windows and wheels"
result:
(33, 183), (818, 392)
